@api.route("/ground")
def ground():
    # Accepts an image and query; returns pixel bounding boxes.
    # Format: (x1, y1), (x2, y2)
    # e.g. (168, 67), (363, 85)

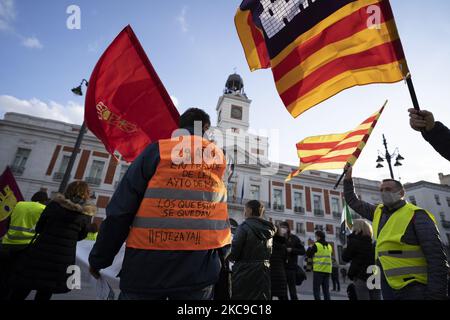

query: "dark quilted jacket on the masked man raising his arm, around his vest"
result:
(344, 180), (449, 299)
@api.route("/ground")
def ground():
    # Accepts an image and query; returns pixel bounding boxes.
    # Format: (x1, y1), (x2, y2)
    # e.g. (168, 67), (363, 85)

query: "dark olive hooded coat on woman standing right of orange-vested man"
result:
(229, 217), (275, 300)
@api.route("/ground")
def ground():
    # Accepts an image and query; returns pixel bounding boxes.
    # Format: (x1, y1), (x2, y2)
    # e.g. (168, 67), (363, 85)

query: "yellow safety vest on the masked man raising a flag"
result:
(373, 203), (436, 290)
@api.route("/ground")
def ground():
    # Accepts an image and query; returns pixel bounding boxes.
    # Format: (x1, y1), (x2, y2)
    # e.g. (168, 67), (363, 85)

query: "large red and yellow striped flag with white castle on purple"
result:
(235, 0), (409, 117)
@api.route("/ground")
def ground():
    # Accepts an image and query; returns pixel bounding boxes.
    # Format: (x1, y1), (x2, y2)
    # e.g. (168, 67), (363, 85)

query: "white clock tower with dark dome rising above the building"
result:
(216, 73), (251, 133)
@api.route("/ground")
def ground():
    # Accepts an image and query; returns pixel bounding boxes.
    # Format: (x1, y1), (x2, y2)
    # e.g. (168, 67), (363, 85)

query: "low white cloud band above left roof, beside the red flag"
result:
(0, 95), (84, 124)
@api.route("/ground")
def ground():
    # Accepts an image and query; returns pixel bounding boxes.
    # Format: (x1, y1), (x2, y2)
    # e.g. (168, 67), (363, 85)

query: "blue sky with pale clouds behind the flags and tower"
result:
(0, 0), (450, 182)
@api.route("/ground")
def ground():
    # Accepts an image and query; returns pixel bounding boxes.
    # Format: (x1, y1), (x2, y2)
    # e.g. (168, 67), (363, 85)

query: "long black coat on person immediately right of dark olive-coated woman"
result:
(270, 235), (288, 297)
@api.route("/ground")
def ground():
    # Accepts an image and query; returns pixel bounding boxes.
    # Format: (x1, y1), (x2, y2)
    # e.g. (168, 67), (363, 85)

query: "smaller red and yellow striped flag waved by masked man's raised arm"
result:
(286, 101), (387, 181)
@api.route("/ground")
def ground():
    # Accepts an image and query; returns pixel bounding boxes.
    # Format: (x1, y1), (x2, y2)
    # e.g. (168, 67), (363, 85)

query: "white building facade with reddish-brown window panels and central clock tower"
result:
(0, 74), (450, 262)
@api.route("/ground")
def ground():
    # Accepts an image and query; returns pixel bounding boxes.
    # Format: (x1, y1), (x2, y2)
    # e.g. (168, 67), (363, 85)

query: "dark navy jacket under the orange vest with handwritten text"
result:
(89, 131), (230, 294)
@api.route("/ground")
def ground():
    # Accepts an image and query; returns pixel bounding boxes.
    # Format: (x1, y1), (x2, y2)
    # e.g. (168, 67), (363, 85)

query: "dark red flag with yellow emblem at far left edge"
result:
(0, 167), (24, 237)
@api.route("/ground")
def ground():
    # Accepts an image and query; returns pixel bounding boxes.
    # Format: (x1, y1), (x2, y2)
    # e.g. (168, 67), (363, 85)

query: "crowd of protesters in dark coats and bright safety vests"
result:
(0, 109), (450, 300)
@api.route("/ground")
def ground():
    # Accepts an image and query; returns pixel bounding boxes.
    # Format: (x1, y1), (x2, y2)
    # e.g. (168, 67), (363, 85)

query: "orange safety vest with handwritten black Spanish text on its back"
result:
(127, 136), (231, 250)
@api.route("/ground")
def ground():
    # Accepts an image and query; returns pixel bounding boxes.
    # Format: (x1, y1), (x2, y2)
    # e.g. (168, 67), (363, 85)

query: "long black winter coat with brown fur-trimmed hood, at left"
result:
(13, 194), (96, 293)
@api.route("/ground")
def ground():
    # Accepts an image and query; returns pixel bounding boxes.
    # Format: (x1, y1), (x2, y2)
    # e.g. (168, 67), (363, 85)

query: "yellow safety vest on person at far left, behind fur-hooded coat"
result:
(2, 201), (45, 245)
